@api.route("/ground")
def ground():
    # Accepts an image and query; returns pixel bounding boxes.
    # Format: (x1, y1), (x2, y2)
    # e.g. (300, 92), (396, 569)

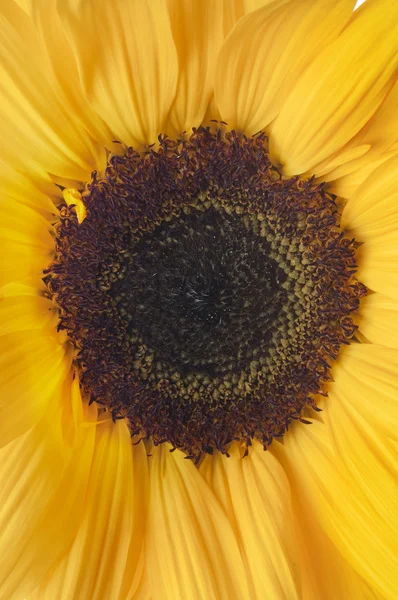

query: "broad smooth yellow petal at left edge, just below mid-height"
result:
(0, 330), (72, 446)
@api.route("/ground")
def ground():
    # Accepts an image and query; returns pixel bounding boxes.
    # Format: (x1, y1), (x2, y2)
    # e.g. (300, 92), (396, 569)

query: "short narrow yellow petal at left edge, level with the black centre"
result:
(0, 293), (58, 336)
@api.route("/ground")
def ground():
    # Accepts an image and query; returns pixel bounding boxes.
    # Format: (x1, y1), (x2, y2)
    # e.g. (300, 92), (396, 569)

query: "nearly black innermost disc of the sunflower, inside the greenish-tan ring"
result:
(111, 209), (284, 376)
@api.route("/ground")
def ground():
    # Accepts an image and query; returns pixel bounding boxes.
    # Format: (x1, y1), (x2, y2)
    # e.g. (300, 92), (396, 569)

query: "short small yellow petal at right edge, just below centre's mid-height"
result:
(356, 293), (398, 348)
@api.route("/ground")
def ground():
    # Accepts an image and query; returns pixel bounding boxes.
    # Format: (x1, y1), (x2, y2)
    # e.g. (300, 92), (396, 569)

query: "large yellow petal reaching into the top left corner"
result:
(0, 2), (104, 180)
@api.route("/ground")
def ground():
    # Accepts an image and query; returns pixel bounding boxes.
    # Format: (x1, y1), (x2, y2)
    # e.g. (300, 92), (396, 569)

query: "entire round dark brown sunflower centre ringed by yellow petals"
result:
(45, 129), (365, 458)
